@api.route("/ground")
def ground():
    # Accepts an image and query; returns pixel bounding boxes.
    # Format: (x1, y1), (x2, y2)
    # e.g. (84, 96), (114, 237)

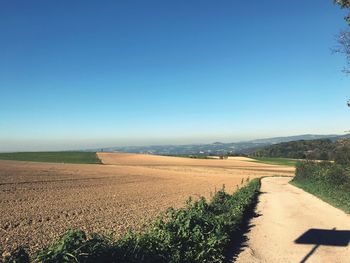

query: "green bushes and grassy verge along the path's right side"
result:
(291, 161), (350, 213)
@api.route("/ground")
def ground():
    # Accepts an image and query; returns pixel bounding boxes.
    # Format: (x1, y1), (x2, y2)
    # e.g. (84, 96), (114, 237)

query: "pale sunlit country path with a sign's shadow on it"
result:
(237, 177), (350, 263)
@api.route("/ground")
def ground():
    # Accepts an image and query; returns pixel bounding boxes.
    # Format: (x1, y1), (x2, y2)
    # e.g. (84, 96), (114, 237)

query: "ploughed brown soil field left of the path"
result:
(0, 153), (294, 255)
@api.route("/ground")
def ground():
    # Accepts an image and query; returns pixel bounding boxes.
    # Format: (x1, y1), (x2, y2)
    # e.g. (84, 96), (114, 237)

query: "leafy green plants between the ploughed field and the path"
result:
(4, 179), (260, 263)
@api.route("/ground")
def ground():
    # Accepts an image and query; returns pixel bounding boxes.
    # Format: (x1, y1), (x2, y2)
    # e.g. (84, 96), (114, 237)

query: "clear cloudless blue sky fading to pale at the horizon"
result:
(0, 0), (350, 151)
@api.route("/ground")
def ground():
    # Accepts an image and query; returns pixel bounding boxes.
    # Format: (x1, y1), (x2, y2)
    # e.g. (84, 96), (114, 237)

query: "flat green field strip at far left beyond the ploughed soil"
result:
(0, 151), (101, 164)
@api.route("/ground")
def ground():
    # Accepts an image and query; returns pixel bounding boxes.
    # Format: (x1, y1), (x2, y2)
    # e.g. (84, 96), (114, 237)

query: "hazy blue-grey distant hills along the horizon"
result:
(98, 134), (350, 155)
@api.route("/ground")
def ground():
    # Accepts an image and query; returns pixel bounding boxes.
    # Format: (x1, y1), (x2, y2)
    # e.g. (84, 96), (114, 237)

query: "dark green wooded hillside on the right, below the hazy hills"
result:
(249, 139), (350, 164)
